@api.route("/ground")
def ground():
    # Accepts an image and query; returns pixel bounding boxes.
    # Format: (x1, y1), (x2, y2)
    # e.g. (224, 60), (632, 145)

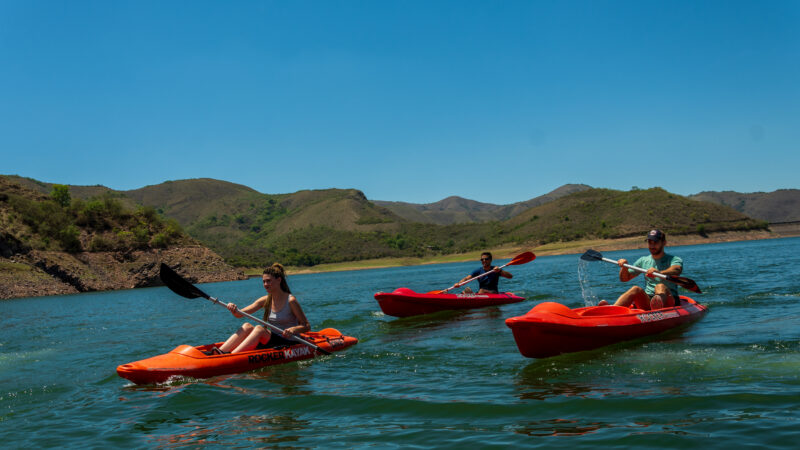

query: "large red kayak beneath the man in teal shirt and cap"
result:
(506, 296), (708, 358)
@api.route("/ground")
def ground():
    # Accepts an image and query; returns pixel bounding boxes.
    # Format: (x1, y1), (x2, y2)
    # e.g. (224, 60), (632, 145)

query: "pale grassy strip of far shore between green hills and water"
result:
(272, 223), (800, 278)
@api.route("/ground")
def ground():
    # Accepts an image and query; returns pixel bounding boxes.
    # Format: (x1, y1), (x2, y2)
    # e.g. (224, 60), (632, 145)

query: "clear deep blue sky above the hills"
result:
(0, 0), (800, 204)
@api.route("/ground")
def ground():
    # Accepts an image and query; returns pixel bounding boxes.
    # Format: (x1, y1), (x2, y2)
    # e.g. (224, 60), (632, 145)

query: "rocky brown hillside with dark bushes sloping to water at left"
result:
(0, 176), (245, 299)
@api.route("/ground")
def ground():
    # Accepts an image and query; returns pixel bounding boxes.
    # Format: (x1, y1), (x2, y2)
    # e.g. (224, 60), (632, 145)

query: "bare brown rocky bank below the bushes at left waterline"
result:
(0, 245), (247, 299)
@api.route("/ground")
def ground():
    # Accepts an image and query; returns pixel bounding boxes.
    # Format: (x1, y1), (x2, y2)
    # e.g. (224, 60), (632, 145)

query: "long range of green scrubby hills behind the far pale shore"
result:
(119, 179), (766, 266)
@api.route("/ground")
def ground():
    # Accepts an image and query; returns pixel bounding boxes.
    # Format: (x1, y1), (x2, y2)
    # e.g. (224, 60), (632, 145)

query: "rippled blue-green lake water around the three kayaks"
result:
(0, 238), (800, 448)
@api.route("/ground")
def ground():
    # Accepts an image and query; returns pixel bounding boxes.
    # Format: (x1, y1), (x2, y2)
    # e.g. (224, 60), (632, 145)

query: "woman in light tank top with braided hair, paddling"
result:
(212, 263), (311, 354)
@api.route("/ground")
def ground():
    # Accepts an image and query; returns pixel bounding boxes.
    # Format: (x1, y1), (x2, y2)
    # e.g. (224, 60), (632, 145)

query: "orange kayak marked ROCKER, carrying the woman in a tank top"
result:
(117, 328), (358, 384)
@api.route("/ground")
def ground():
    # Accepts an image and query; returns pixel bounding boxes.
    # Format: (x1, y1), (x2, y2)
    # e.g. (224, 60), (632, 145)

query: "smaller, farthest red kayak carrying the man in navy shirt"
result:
(375, 288), (525, 317)
